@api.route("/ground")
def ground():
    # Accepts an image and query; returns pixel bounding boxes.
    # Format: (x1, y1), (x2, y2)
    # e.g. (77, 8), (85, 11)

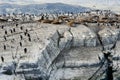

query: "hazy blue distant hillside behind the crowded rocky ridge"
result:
(0, 3), (90, 14)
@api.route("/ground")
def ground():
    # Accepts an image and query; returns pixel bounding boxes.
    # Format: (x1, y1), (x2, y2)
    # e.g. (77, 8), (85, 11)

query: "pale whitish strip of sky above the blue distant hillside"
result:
(0, 0), (120, 5)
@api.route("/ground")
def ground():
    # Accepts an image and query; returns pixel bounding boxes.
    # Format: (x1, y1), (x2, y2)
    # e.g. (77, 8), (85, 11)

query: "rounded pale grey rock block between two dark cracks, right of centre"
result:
(71, 25), (97, 47)
